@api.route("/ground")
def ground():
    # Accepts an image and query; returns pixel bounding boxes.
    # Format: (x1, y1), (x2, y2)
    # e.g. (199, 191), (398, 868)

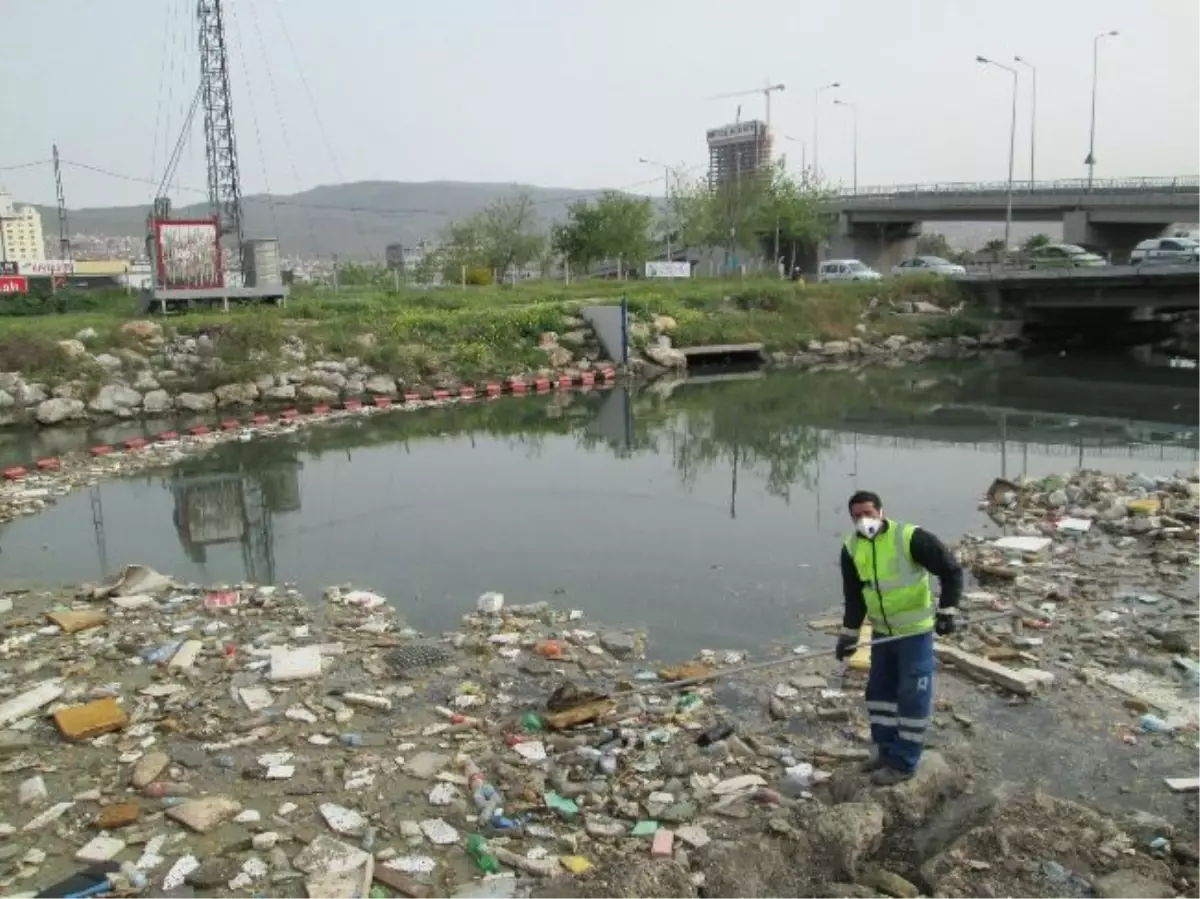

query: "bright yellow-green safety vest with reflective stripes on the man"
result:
(846, 521), (937, 636)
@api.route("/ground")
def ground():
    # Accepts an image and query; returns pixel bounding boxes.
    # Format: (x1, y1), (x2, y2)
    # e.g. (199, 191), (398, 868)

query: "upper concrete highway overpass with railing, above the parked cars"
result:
(826, 175), (1200, 268)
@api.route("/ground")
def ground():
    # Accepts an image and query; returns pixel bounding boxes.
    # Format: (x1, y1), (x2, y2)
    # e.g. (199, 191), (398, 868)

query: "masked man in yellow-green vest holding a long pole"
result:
(838, 491), (962, 786)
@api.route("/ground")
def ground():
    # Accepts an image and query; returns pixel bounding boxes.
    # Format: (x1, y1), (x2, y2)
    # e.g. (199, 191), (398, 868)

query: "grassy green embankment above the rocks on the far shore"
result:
(0, 278), (980, 383)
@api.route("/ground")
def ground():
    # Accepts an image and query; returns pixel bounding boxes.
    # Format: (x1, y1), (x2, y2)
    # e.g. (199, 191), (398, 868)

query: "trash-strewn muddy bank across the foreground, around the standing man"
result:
(7, 456), (1200, 899)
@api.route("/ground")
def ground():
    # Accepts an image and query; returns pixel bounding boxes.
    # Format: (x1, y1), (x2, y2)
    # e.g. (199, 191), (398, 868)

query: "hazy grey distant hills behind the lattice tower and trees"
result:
(40, 181), (609, 262)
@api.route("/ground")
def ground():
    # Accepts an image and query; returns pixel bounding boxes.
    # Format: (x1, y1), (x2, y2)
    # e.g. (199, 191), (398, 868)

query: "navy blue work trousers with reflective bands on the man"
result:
(866, 631), (934, 772)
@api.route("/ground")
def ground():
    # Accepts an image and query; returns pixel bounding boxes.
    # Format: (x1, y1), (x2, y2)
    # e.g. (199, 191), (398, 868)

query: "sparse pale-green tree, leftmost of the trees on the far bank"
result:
(443, 192), (546, 281)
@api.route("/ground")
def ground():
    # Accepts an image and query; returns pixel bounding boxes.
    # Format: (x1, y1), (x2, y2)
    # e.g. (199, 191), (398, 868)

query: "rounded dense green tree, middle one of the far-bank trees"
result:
(551, 191), (654, 271)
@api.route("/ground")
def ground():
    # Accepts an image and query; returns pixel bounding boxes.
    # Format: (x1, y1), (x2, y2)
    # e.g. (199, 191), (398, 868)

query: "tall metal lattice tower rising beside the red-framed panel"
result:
(196, 0), (245, 269)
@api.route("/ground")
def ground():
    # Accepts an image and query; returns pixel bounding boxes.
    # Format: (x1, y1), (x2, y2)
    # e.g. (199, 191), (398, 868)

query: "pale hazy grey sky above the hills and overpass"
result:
(0, 0), (1200, 208)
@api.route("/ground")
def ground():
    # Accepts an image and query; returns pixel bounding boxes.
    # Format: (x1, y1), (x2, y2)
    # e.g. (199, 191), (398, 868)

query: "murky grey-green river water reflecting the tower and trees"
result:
(0, 359), (1200, 658)
